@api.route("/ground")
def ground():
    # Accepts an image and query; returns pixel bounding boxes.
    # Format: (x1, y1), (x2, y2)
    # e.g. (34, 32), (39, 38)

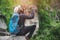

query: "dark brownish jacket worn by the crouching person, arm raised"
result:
(18, 10), (34, 26)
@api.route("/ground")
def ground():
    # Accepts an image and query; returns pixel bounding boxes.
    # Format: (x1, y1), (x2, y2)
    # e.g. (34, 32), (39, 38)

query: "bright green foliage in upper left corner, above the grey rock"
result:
(0, 0), (13, 30)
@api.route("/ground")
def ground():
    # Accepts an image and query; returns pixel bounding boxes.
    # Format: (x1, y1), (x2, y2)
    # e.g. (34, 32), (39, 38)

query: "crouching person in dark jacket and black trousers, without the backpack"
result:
(16, 4), (36, 40)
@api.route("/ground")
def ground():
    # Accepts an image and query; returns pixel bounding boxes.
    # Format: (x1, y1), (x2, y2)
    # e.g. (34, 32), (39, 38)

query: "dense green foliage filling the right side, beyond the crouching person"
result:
(31, 0), (60, 40)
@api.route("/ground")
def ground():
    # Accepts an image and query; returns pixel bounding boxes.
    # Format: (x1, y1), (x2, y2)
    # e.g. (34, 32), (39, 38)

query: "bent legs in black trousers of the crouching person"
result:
(17, 25), (36, 39)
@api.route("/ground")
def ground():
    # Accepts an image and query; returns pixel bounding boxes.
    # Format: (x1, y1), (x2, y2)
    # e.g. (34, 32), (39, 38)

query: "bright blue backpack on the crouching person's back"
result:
(9, 13), (19, 34)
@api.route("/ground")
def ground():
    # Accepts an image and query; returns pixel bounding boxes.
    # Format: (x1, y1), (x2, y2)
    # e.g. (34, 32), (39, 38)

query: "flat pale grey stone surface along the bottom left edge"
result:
(0, 36), (26, 40)
